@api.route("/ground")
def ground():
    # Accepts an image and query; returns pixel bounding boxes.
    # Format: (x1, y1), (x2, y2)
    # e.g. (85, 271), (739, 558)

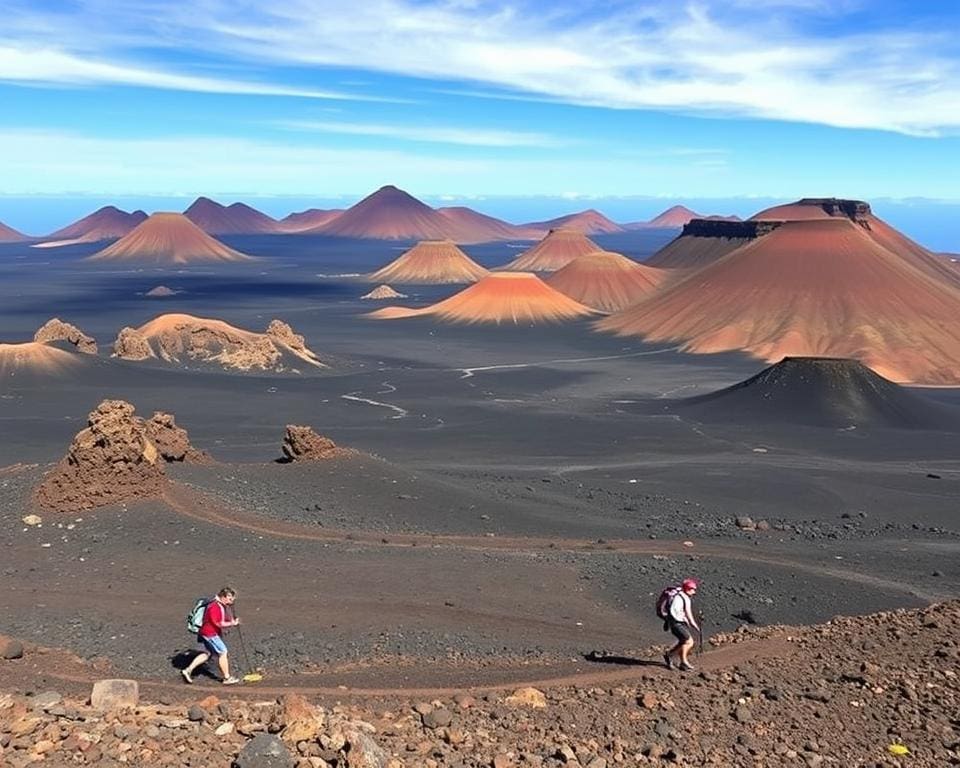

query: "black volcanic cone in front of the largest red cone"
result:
(675, 357), (960, 431)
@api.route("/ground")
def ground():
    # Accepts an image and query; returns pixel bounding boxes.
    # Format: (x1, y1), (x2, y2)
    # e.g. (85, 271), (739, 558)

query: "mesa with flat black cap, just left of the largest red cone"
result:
(643, 219), (780, 270)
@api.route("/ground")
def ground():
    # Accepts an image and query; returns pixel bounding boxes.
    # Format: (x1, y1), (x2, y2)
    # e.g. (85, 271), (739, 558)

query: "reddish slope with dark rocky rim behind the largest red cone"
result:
(750, 197), (960, 287)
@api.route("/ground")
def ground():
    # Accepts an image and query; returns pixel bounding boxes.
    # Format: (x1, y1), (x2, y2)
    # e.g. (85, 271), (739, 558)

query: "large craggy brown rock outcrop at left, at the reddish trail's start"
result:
(34, 400), (206, 512)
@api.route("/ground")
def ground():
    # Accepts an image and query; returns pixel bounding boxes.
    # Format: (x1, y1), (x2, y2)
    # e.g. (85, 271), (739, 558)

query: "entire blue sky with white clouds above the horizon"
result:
(0, 0), (960, 237)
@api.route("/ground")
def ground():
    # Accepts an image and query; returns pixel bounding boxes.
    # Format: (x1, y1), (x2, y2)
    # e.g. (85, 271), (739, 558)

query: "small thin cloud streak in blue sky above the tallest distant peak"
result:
(274, 120), (572, 148)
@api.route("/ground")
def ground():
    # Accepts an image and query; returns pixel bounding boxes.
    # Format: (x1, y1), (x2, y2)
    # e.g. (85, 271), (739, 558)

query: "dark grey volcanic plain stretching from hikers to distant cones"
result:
(0, 218), (960, 764)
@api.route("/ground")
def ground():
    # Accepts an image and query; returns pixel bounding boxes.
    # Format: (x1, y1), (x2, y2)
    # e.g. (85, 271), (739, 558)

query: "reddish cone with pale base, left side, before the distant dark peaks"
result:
(87, 213), (254, 264)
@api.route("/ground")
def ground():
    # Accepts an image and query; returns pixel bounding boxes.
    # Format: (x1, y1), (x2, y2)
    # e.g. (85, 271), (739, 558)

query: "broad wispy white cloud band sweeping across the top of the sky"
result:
(0, 0), (960, 135)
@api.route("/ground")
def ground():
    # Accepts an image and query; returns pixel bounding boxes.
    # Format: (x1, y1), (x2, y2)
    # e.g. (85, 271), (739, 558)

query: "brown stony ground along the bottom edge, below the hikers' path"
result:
(0, 601), (960, 768)
